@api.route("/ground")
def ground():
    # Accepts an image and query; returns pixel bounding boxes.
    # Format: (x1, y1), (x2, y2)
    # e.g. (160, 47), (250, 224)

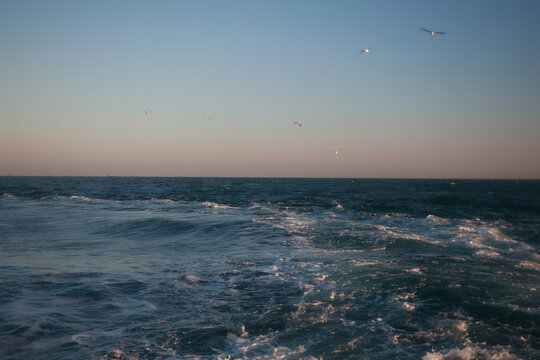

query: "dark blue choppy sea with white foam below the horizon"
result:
(0, 177), (540, 360)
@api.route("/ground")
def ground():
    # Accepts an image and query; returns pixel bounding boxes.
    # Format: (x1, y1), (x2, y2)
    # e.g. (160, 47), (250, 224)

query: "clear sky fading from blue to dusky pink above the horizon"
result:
(0, 0), (540, 179)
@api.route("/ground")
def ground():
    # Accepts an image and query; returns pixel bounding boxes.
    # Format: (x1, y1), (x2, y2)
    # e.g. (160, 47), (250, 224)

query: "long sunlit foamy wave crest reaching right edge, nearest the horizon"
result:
(248, 203), (536, 260)
